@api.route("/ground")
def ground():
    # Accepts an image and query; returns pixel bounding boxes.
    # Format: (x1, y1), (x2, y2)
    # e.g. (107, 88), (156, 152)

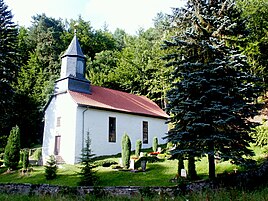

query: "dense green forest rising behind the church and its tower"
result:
(0, 0), (268, 153)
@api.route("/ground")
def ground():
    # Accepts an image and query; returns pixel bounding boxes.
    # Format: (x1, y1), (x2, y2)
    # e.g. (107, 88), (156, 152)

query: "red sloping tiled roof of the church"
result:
(69, 85), (168, 118)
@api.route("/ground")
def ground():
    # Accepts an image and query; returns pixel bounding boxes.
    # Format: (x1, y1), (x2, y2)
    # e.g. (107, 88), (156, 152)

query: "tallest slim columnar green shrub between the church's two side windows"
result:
(121, 133), (131, 169)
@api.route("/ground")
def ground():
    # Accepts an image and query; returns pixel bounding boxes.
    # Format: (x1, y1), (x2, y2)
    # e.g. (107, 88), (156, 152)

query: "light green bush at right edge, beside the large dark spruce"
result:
(250, 124), (268, 147)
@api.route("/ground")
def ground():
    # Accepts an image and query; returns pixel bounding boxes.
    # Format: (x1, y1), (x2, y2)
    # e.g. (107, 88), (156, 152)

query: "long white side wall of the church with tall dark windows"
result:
(76, 107), (168, 162)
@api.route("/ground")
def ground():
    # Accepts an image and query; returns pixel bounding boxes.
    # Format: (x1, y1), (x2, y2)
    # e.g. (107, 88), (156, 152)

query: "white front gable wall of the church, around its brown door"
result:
(42, 93), (77, 164)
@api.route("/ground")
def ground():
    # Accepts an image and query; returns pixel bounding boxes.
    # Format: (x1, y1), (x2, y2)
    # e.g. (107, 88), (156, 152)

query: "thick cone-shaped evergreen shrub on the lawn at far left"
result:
(4, 126), (20, 169)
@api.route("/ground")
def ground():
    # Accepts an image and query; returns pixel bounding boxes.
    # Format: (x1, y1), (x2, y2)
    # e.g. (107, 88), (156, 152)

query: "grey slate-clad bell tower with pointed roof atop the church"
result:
(54, 33), (90, 94)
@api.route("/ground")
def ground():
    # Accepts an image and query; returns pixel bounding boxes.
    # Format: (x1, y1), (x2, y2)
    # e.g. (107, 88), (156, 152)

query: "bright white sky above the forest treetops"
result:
(4, 0), (184, 34)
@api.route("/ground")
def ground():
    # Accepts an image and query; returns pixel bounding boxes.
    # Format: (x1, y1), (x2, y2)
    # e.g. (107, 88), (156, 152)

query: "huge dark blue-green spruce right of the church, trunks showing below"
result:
(165, 0), (258, 179)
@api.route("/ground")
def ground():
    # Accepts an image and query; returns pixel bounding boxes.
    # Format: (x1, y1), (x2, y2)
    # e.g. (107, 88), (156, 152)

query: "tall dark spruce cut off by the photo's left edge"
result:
(0, 0), (18, 148)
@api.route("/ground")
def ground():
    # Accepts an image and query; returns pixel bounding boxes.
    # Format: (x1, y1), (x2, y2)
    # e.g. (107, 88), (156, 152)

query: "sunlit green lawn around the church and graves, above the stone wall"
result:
(0, 144), (265, 186)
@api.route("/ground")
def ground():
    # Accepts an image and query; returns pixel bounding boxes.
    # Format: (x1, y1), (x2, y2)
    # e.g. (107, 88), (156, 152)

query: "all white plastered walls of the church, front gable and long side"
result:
(42, 93), (168, 164)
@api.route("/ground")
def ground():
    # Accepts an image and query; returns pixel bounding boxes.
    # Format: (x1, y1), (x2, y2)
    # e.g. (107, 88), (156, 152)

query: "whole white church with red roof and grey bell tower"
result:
(42, 35), (168, 164)
